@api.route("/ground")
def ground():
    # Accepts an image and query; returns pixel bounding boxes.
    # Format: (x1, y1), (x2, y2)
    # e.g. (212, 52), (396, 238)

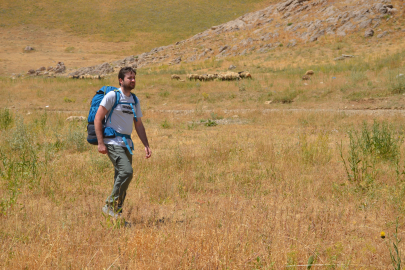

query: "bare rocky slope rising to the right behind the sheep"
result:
(68, 0), (405, 76)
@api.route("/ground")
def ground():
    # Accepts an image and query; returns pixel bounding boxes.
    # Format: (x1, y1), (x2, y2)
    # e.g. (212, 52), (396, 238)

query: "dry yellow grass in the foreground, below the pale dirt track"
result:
(0, 105), (404, 269)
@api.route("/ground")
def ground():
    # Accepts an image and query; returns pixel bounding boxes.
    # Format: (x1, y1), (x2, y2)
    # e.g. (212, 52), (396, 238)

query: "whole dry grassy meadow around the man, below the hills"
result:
(0, 41), (405, 269)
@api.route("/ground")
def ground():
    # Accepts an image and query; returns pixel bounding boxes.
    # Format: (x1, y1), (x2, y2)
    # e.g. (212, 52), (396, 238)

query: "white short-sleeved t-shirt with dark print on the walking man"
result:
(100, 89), (142, 147)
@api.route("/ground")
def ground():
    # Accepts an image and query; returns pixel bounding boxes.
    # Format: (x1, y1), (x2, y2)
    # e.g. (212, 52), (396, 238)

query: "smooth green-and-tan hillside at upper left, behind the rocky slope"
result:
(0, 0), (274, 74)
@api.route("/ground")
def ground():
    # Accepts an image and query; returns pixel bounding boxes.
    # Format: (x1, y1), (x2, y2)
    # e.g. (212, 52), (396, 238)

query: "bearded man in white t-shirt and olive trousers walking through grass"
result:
(94, 67), (152, 218)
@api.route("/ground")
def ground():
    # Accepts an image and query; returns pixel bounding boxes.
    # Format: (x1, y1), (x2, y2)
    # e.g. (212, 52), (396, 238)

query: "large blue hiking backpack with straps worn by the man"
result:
(87, 86), (138, 155)
